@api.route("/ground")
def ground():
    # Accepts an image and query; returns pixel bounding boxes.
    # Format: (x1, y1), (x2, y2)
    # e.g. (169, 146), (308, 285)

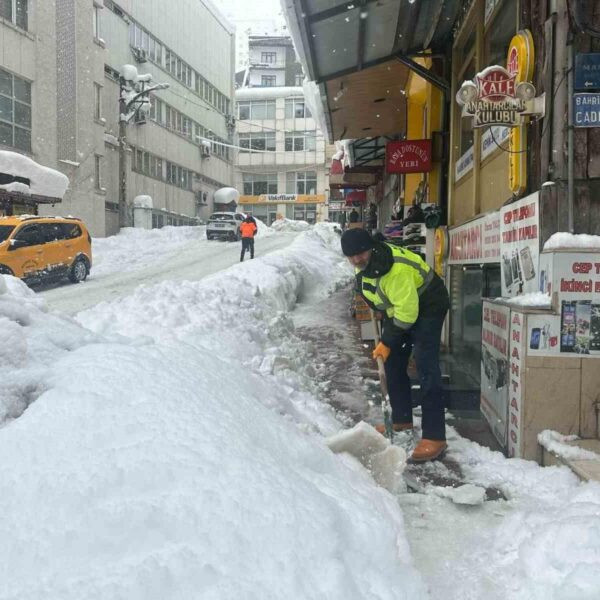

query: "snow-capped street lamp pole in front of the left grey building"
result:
(119, 65), (169, 228)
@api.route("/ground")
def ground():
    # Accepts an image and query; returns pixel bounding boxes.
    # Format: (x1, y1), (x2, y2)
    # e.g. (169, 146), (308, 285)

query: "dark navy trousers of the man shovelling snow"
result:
(384, 312), (446, 440)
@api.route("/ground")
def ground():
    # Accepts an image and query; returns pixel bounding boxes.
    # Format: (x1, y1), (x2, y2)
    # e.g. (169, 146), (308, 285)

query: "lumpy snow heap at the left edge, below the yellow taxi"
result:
(0, 275), (99, 425)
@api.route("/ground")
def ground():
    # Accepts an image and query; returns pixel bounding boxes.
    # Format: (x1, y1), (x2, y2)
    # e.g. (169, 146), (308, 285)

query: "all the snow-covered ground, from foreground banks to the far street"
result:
(0, 224), (600, 600)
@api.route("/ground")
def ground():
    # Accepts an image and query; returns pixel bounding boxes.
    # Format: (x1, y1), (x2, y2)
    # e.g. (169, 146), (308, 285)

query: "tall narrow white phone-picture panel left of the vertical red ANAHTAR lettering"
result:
(481, 300), (510, 448)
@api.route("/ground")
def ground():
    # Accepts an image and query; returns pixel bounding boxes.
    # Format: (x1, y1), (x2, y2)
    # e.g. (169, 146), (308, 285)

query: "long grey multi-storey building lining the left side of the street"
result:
(0, 0), (235, 236)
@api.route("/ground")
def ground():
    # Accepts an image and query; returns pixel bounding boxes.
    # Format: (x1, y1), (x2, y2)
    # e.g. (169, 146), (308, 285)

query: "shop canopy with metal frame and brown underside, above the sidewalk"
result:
(282, 0), (462, 141)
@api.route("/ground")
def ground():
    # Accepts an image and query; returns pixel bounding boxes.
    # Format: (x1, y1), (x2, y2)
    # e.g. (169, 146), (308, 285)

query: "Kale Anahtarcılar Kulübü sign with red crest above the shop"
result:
(456, 65), (543, 127)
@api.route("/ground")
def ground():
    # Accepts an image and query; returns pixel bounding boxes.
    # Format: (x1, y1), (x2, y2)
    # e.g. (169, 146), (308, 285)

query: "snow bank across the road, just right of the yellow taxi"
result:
(90, 226), (206, 279)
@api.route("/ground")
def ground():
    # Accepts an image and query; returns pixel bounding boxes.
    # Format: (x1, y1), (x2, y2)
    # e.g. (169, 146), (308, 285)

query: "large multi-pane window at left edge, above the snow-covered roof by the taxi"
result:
(0, 69), (31, 152)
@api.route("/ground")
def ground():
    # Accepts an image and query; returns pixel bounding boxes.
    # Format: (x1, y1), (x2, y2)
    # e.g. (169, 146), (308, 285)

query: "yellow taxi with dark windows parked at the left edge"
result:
(0, 215), (92, 283)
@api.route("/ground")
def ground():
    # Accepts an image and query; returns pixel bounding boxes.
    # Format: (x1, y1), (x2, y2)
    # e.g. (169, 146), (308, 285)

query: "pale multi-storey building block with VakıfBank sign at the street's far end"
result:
(234, 36), (332, 225)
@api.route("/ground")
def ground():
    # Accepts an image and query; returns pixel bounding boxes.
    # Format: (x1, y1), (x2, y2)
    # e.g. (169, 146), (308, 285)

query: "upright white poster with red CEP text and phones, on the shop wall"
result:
(500, 192), (540, 298)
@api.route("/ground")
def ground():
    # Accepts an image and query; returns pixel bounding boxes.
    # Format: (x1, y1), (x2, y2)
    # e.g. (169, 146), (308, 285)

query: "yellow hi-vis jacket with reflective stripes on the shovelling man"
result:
(356, 244), (435, 329)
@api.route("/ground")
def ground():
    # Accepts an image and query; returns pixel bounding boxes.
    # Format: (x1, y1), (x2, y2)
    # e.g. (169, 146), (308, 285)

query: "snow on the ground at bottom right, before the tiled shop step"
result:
(426, 427), (600, 600)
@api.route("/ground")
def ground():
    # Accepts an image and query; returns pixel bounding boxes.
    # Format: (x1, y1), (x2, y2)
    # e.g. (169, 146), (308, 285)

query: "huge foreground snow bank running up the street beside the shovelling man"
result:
(0, 227), (427, 600)
